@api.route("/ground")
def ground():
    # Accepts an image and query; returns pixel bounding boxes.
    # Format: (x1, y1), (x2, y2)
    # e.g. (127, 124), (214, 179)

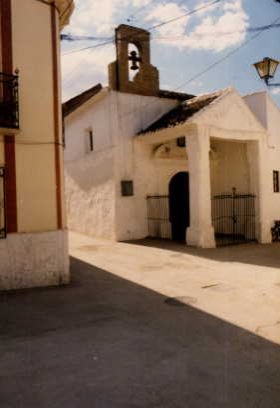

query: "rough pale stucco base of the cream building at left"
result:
(0, 231), (70, 290)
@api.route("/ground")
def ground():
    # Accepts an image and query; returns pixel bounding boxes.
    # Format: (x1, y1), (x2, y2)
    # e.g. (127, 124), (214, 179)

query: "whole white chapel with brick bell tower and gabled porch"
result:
(63, 25), (280, 248)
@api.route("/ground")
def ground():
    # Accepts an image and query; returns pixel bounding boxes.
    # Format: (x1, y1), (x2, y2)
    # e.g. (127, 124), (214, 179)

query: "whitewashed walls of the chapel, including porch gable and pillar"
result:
(65, 88), (280, 247)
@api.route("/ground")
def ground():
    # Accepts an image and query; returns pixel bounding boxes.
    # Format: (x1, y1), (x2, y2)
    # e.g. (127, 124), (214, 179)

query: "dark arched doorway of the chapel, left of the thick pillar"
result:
(169, 172), (190, 241)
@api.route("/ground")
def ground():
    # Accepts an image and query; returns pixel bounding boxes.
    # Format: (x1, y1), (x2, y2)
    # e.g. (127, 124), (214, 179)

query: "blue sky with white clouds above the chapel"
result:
(62, 0), (280, 107)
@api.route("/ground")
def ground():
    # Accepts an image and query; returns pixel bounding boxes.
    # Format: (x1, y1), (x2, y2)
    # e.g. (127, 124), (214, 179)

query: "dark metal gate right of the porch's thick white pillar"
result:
(212, 188), (256, 246)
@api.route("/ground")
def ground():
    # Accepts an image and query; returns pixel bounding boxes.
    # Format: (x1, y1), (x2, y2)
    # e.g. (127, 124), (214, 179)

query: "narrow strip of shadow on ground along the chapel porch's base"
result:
(125, 238), (280, 268)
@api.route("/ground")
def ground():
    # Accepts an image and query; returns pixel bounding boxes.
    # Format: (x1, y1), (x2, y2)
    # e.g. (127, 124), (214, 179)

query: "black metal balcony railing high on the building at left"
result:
(0, 72), (19, 129)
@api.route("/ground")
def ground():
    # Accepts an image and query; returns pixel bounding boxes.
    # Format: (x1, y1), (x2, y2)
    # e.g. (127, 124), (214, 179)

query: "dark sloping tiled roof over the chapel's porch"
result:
(139, 90), (225, 134)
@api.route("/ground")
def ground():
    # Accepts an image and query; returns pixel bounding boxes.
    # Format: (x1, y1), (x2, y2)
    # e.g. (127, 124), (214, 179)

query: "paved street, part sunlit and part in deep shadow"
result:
(0, 234), (280, 408)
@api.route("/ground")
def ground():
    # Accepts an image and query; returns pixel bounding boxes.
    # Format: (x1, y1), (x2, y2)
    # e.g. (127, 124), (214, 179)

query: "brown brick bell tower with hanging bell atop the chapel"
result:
(109, 24), (159, 96)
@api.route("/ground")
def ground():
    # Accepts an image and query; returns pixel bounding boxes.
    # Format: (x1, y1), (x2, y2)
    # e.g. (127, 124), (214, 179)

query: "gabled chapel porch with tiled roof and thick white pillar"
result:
(137, 90), (271, 248)
